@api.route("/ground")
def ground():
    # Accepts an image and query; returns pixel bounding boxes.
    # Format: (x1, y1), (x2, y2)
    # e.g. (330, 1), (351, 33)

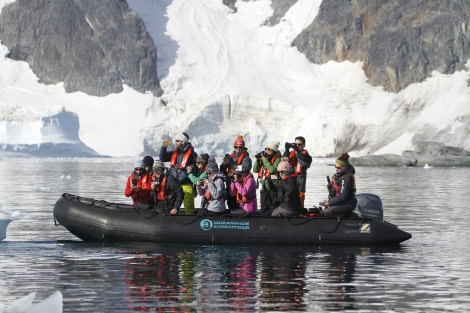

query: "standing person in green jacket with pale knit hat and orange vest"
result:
(253, 141), (281, 216)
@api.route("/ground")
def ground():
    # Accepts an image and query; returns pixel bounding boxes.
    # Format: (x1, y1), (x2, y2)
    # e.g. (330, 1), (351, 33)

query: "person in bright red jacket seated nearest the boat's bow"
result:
(124, 160), (153, 209)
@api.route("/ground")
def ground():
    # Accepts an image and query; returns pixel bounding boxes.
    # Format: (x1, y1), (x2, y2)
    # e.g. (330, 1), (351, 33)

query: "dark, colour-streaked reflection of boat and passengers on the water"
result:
(114, 242), (401, 312)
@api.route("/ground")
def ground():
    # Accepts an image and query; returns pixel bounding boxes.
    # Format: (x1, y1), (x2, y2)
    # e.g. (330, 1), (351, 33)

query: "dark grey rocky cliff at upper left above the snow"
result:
(0, 0), (161, 96)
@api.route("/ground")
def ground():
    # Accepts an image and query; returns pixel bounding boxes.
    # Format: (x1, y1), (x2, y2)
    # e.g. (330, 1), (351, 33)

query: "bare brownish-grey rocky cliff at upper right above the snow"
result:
(293, 0), (470, 92)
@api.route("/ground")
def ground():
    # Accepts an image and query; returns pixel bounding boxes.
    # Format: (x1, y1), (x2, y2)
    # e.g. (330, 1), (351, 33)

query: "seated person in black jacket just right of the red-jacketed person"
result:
(151, 160), (184, 215)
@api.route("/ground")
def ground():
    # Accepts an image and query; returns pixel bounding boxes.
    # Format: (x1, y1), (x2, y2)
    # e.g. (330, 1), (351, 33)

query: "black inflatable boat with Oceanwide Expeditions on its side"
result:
(54, 194), (411, 245)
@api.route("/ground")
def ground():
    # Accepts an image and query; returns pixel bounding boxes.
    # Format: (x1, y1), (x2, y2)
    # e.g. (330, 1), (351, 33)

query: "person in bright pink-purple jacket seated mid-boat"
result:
(230, 165), (258, 215)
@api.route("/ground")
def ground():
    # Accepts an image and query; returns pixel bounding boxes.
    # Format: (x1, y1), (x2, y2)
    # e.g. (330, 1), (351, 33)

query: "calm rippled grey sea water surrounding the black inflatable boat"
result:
(0, 159), (470, 312)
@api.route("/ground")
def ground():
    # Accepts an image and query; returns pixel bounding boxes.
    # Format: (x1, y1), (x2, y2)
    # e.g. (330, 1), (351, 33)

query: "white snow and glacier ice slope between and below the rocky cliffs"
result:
(0, 0), (470, 157)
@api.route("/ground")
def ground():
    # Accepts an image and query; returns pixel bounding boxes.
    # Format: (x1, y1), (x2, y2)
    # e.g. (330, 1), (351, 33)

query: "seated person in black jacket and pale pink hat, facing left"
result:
(271, 158), (302, 217)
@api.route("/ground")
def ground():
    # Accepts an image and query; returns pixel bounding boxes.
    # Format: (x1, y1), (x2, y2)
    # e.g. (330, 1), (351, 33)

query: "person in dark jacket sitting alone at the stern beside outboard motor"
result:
(322, 153), (357, 217)
